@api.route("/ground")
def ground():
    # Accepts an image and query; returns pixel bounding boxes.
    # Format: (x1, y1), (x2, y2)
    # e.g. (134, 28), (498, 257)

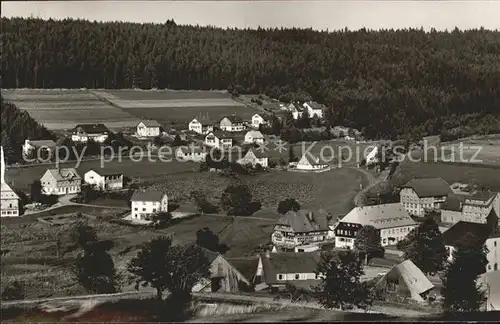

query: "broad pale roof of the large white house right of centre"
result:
(340, 203), (417, 229)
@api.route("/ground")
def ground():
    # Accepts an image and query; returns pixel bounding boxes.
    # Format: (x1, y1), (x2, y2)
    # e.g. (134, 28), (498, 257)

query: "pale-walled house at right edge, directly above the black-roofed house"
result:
(441, 191), (500, 224)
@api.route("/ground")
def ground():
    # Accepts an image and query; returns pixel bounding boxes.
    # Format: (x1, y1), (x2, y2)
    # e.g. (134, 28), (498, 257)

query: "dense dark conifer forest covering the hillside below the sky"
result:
(2, 18), (500, 138)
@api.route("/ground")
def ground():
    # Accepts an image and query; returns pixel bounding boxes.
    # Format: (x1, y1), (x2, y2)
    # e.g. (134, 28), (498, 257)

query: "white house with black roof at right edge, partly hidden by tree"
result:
(443, 218), (500, 272)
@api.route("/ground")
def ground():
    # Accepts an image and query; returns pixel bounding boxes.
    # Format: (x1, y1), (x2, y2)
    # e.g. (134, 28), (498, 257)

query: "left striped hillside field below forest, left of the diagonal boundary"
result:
(2, 89), (143, 130)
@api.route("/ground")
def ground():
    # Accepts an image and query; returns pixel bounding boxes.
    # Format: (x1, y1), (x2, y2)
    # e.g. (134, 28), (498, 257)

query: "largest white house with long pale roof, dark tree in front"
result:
(335, 203), (418, 249)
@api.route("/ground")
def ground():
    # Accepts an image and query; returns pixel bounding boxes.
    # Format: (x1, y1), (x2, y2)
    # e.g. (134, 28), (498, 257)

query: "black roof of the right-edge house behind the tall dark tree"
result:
(443, 221), (492, 246)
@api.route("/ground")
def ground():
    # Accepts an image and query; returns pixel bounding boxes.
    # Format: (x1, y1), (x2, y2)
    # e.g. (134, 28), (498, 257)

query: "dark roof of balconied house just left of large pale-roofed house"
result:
(278, 209), (328, 233)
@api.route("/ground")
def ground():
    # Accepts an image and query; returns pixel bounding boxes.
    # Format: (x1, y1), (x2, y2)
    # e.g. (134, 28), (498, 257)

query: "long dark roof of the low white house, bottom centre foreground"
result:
(260, 252), (321, 284)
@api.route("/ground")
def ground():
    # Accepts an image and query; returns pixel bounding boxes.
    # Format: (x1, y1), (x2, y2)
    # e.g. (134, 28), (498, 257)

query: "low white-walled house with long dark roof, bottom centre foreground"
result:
(254, 251), (321, 291)
